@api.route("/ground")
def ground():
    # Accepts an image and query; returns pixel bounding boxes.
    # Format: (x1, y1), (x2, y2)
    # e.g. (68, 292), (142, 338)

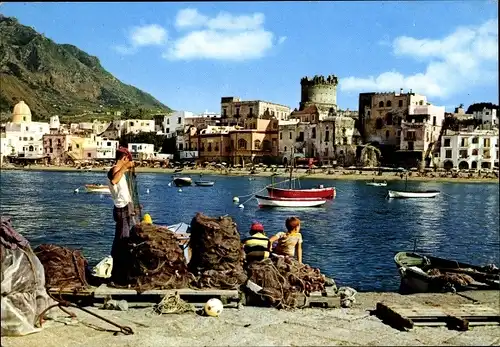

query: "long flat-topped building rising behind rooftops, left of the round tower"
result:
(220, 96), (291, 125)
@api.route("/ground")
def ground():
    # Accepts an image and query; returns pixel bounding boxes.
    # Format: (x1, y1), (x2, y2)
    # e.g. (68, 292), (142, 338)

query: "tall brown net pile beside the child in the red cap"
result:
(189, 213), (247, 289)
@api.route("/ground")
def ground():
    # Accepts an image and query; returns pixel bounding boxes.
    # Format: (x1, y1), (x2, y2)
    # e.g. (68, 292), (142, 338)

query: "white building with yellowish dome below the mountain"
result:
(1, 101), (50, 159)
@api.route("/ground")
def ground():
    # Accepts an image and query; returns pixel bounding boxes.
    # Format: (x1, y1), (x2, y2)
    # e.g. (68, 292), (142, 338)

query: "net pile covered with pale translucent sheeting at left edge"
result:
(0, 216), (53, 336)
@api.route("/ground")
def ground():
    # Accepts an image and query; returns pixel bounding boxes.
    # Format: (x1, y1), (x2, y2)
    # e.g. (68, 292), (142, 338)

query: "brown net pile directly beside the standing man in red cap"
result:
(113, 223), (193, 292)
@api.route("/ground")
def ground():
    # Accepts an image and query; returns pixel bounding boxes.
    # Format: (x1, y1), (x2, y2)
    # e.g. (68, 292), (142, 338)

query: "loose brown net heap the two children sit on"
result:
(248, 257), (325, 308)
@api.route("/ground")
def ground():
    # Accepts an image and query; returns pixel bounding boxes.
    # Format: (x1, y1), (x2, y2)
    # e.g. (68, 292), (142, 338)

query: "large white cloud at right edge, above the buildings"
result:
(340, 20), (498, 98)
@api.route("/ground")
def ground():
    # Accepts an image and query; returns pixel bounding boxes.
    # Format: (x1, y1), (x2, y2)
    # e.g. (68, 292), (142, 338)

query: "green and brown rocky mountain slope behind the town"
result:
(0, 14), (170, 119)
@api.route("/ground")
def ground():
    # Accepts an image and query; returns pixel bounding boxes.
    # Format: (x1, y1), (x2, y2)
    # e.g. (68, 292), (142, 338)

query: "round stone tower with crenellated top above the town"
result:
(300, 75), (338, 114)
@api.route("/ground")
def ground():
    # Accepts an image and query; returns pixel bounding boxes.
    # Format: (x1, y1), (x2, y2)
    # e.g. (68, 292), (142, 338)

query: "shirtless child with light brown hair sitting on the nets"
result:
(269, 217), (302, 263)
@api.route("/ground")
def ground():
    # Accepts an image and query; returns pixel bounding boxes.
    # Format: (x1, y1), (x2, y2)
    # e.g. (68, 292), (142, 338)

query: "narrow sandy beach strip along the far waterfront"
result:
(1, 165), (499, 184)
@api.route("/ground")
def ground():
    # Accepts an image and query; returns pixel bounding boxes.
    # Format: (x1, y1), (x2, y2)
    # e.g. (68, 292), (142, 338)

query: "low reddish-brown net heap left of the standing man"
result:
(34, 245), (88, 290)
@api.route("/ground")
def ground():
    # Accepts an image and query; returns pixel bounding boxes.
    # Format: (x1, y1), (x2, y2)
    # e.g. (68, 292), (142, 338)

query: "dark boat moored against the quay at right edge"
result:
(394, 252), (500, 294)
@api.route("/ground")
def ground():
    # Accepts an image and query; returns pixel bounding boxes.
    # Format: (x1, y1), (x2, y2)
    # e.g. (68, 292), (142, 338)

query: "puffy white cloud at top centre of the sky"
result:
(163, 8), (279, 61)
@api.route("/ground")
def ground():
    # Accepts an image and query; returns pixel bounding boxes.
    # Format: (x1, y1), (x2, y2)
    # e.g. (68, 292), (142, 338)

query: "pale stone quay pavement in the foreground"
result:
(2, 291), (500, 347)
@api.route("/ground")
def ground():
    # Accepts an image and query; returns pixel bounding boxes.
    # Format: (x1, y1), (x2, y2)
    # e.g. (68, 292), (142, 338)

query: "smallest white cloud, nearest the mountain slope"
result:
(113, 24), (168, 54)
